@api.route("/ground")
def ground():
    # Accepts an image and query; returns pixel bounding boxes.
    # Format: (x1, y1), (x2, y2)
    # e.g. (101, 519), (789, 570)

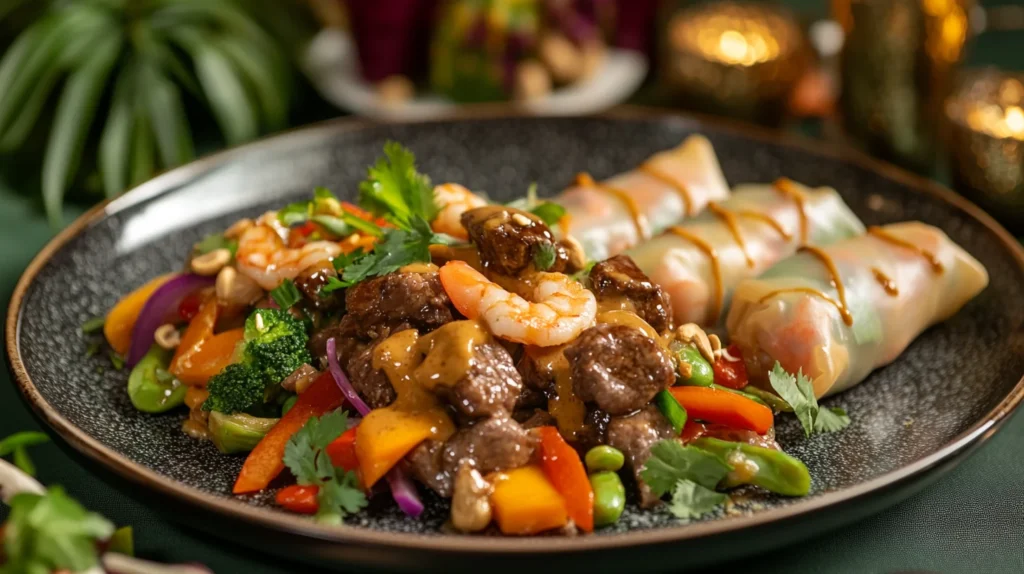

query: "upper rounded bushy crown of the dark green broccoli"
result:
(244, 309), (312, 384)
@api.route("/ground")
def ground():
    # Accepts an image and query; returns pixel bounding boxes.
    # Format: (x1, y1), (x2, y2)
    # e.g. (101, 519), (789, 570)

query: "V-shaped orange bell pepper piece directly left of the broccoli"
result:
(167, 297), (245, 387)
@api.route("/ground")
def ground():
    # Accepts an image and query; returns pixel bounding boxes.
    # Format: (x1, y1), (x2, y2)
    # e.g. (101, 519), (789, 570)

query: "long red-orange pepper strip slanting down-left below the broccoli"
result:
(232, 371), (344, 494)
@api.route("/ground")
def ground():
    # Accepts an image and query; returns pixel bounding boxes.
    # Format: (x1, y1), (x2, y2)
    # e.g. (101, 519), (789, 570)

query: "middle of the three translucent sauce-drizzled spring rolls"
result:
(627, 179), (864, 326)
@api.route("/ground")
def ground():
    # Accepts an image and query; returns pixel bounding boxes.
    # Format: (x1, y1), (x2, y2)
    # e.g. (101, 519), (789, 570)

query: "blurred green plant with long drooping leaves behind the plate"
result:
(0, 0), (307, 226)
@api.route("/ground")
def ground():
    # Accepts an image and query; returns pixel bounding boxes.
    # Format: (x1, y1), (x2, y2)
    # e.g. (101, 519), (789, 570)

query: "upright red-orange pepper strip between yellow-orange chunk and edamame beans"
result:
(538, 427), (594, 532)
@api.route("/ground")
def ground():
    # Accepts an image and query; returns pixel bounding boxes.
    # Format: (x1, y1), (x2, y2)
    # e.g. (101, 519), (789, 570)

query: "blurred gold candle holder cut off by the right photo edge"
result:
(946, 69), (1024, 233)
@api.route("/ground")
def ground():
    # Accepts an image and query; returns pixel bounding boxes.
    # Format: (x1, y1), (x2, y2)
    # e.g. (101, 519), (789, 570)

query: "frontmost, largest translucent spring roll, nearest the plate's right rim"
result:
(726, 222), (988, 397)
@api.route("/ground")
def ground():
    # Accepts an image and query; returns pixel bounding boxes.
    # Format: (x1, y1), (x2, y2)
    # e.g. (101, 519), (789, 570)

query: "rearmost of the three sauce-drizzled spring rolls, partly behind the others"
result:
(553, 135), (729, 261)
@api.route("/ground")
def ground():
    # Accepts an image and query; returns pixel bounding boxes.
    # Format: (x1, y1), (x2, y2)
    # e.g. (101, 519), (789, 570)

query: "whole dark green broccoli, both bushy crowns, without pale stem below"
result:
(203, 309), (312, 414)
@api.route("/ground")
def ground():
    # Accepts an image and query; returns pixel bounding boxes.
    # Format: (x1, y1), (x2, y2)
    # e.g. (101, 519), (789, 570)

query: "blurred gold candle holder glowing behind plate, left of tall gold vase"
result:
(660, 2), (810, 125)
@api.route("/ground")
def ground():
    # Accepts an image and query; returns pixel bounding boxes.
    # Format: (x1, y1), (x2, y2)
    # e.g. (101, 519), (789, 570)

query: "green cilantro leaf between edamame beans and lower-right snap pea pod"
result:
(640, 439), (732, 496)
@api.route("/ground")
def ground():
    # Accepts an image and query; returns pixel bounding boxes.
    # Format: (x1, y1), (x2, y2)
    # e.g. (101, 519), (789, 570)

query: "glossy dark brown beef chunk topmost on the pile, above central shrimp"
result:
(462, 206), (568, 276)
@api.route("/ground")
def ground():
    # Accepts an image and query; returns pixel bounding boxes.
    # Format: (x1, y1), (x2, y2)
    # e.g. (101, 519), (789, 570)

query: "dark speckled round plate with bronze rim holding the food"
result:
(7, 111), (1024, 571)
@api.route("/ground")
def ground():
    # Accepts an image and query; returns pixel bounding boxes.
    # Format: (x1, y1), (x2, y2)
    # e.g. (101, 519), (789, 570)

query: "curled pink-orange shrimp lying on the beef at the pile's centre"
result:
(440, 261), (597, 347)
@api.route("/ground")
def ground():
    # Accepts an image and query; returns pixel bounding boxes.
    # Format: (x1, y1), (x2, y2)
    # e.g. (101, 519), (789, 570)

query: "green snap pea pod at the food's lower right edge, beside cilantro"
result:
(691, 437), (811, 496)
